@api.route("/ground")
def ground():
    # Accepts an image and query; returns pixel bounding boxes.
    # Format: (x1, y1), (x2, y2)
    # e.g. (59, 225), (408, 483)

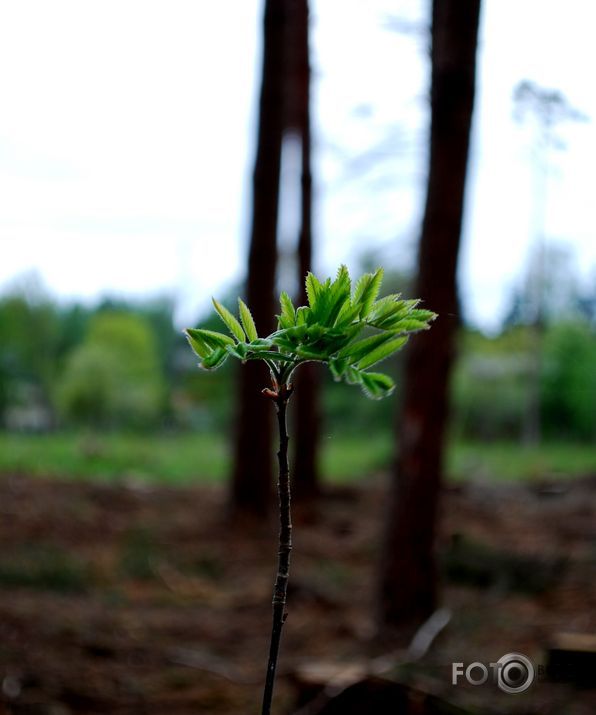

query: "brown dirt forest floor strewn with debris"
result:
(0, 475), (596, 715)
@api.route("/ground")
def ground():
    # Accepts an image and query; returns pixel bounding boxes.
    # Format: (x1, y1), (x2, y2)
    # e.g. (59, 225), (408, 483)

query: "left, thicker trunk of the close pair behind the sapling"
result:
(230, 0), (286, 516)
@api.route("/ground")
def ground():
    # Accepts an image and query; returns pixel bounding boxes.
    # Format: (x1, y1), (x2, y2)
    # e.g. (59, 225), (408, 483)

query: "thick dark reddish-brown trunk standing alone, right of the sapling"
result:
(379, 0), (480, 641)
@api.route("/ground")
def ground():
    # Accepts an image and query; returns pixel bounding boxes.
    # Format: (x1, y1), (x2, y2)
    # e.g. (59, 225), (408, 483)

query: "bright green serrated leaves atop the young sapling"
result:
(185, 266), (436, 399)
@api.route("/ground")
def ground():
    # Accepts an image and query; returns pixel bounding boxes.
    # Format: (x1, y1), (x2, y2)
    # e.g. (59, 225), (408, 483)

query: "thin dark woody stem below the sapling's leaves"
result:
(261, 384), (292, 715)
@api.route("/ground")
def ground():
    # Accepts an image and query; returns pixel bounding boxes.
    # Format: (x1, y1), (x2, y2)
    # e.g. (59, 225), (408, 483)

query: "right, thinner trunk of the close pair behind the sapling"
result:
(286, 0), (320, 499)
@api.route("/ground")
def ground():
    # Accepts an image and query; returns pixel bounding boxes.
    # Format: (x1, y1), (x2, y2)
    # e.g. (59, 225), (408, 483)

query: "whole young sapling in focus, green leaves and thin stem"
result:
(185, 266), (436, 715)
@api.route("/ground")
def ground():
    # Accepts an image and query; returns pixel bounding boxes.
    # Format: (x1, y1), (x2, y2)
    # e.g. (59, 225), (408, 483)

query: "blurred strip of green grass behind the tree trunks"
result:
(0, 431), (596, 484)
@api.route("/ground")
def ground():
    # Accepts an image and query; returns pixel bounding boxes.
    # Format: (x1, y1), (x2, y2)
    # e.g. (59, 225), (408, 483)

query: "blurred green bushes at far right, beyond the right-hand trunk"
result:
(452, 320), (596, 440)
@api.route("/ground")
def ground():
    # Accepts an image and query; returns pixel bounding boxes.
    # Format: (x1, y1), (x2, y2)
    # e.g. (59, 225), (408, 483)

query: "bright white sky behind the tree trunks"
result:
(0, 0), (596, 328)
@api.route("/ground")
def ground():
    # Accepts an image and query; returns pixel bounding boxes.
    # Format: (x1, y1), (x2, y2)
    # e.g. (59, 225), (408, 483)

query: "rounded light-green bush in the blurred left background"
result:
(56, 313), (163, 427)
